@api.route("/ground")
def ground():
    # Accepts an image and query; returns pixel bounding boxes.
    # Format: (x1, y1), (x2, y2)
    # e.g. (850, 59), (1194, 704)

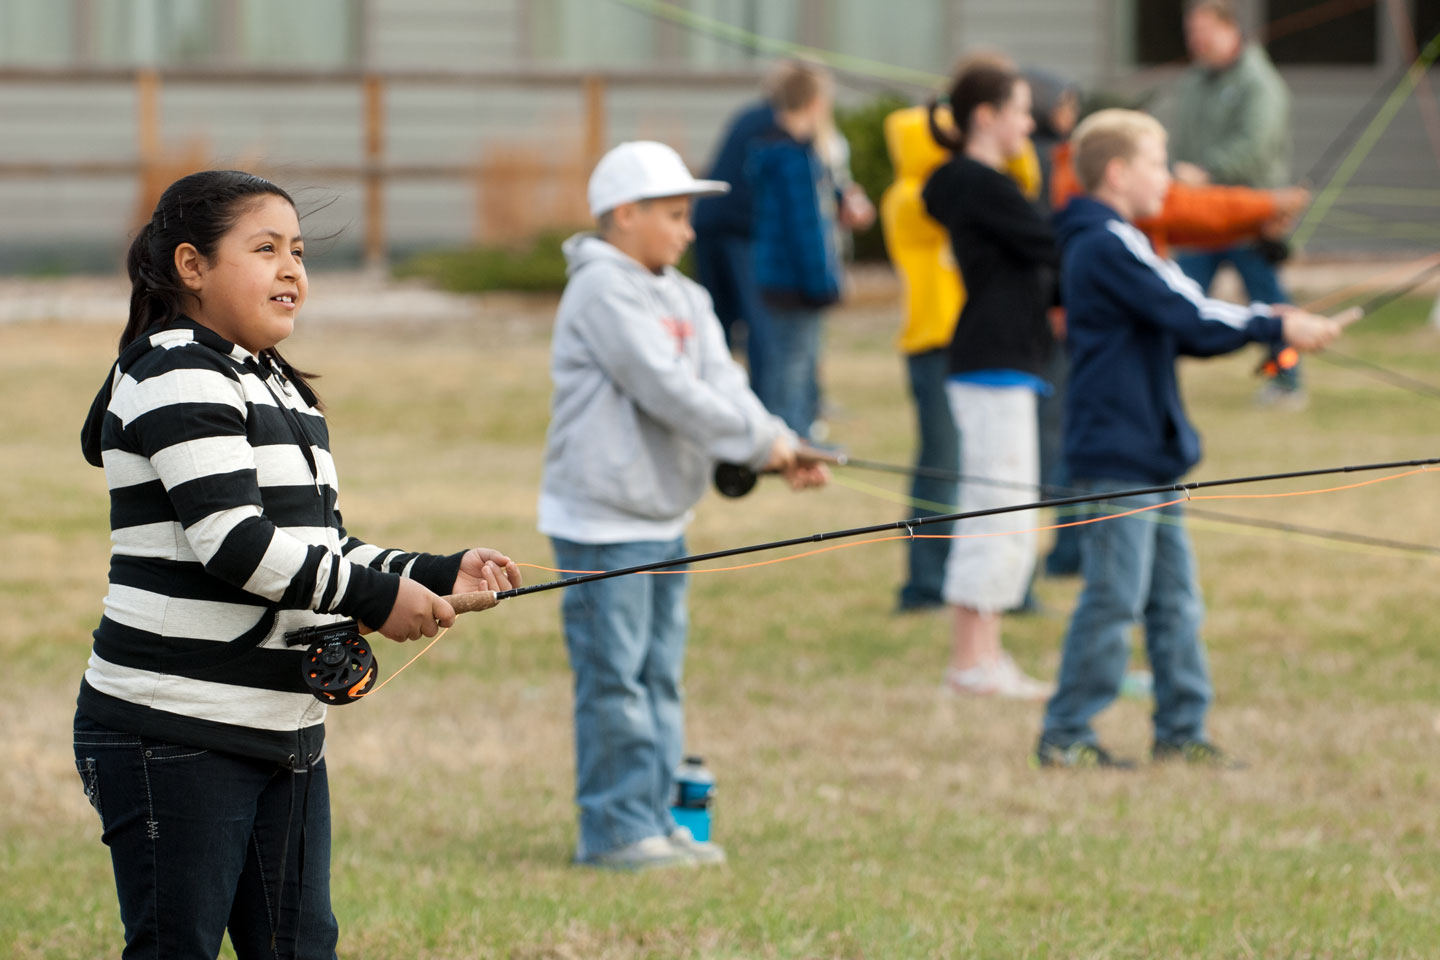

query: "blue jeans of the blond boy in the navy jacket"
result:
(1041, 481), (1211, 747)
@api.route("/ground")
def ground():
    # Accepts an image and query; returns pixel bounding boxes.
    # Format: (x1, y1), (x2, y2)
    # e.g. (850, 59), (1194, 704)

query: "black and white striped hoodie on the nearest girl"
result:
(79, 318), (462, 767)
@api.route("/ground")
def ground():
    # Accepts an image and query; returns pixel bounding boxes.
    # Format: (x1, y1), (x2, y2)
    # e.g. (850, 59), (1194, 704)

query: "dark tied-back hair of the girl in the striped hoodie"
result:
(120, 170), (315, 394)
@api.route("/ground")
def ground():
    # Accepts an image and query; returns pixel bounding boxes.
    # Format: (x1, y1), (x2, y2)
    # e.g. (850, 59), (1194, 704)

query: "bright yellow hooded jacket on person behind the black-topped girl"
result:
(880, 107), (1040, 354)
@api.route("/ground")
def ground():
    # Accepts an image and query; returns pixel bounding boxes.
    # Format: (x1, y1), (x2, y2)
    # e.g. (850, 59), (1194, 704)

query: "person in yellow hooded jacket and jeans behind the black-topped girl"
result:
(880, 107), (1041, 612)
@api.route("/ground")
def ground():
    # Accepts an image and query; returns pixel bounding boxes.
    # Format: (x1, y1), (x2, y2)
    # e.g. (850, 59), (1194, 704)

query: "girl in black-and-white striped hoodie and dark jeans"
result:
(75, 170), (518, 957)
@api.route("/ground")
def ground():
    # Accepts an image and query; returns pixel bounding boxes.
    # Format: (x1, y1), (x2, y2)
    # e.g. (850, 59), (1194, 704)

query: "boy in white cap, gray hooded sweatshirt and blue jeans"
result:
(539, 141), (825, 869)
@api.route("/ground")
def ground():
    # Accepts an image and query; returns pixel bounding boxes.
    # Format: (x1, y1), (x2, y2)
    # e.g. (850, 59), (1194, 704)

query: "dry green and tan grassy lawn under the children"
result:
(0, 282), (1440, 960)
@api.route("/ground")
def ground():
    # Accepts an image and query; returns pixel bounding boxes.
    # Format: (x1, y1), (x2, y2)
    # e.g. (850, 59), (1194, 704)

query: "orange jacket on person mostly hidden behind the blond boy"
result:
(1050, 142), (1276, 256)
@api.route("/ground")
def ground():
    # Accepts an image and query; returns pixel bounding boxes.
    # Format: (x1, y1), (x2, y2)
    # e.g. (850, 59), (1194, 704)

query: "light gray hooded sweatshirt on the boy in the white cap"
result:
(539, 233), (792, 544)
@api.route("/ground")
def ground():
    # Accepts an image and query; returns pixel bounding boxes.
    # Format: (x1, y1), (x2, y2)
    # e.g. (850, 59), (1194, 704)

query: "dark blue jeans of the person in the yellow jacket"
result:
(900, 350), (960, 610)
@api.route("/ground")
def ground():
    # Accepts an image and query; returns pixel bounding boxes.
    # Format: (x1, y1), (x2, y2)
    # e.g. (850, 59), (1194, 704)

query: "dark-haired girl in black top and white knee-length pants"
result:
(923, 60), (1058, 699)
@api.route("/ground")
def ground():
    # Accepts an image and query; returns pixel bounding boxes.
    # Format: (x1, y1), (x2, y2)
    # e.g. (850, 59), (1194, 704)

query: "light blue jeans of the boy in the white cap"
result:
(552, 537), (688, 861)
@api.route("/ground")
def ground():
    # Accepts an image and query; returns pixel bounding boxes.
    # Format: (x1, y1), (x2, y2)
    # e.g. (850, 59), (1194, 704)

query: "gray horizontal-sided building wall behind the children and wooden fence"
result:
(0, 0), (1440, 269)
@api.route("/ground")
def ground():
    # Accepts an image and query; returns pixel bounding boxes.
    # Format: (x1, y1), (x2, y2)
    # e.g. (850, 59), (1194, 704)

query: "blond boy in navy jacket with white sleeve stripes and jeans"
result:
(1035, 109), (1346, 766)
